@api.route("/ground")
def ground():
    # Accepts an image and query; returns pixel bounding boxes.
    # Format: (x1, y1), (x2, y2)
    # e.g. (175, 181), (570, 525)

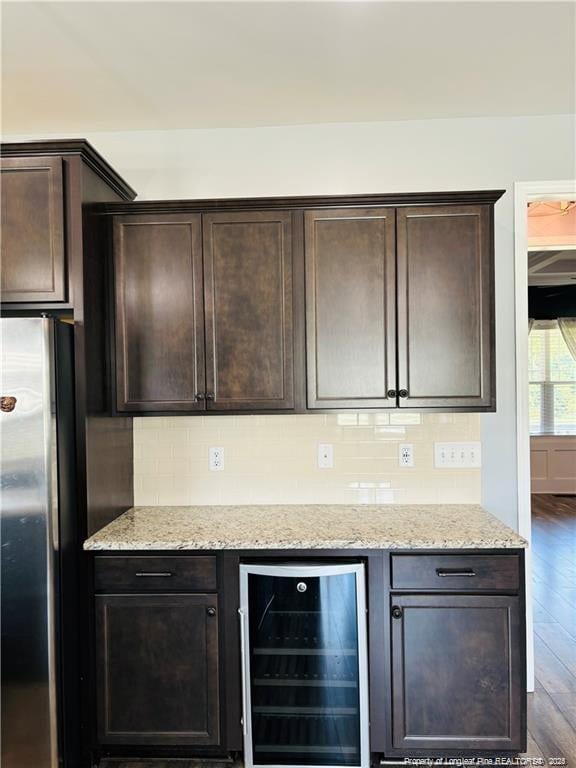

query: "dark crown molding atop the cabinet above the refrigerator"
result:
(0, 139), (136, 201)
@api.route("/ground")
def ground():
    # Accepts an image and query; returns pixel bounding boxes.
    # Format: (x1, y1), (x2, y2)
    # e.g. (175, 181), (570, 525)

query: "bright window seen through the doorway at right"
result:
(529, 320), (576, 435)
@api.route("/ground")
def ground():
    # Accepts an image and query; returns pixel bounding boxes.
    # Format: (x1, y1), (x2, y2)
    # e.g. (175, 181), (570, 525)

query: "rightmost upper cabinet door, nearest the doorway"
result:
(398, 205), (495, 410)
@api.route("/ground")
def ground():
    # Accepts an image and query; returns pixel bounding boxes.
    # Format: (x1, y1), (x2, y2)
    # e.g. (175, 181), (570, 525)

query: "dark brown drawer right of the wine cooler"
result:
(392, 555), (520, 592)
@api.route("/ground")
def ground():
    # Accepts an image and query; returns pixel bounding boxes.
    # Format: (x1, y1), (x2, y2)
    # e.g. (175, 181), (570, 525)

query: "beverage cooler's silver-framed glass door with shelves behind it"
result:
(240, 564), (370, 768)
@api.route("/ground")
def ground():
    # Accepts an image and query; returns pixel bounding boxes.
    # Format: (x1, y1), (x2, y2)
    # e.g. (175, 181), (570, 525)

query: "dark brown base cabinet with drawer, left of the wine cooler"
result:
(94, 555), (220, 747)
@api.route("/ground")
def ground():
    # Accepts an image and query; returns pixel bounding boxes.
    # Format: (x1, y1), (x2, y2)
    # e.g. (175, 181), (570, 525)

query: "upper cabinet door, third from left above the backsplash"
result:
(304, 208), (396, 408)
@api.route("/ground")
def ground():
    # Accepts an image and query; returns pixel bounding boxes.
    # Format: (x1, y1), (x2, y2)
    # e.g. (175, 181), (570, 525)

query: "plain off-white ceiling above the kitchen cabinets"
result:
(2, 1), (576, 134)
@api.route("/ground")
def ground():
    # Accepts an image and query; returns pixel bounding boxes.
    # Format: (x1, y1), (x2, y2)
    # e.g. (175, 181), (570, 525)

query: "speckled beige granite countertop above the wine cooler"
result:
(84, 504), (527, 551)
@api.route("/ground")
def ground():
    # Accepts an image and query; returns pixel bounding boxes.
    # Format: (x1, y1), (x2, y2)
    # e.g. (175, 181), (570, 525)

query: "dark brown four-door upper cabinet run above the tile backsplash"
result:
(106, 191), (502, 413)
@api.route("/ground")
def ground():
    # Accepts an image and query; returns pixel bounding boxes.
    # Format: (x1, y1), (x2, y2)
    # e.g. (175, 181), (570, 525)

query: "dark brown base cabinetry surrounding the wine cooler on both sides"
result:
(94, 550), (526, 760)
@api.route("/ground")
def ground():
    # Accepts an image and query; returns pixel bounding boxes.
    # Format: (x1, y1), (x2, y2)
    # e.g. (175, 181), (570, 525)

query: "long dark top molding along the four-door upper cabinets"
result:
(94, 189), (506, 214)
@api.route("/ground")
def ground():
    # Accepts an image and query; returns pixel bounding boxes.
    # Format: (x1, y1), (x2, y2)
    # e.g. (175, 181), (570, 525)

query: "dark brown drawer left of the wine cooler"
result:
(94, 555), (217, 592)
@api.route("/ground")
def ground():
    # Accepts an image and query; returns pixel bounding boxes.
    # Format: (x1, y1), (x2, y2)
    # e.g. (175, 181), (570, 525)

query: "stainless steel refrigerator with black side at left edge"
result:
(0, 317), (79, 768)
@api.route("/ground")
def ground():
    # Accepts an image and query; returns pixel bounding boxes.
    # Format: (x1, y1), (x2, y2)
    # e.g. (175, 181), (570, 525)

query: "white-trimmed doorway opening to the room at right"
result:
(515, 181), (576, 752)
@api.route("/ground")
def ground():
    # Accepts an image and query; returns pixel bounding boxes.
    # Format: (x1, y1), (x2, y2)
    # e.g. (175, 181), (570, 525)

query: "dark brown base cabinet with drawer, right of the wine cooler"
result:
(388, 550), (526, 755)
